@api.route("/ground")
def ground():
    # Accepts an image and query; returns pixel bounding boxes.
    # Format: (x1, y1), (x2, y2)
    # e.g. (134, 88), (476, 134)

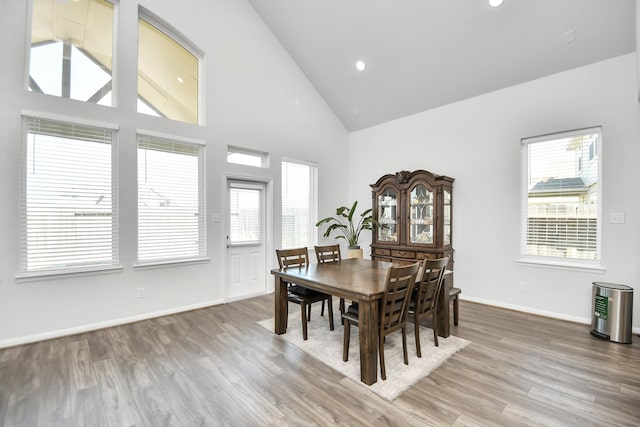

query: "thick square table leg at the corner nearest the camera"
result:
(358, 300), (379, 385)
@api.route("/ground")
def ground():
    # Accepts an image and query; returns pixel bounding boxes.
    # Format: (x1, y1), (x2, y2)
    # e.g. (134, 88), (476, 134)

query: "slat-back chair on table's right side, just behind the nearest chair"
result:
(409, 257), (449, 357)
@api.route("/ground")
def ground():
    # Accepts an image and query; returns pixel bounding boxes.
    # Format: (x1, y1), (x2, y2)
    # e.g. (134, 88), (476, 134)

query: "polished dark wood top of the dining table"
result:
(271, 258), (394, 301)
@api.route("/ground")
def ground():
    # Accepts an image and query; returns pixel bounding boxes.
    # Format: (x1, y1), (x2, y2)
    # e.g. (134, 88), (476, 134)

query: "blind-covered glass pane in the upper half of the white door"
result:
(229, 182), (264, 245)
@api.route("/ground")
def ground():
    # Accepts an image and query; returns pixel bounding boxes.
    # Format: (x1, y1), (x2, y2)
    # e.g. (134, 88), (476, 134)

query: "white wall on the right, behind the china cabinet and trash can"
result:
(349, 54), (640, 332)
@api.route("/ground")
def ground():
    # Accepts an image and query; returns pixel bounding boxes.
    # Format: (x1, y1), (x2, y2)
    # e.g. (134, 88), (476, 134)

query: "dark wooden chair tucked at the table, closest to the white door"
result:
(276, 247), (334, 341)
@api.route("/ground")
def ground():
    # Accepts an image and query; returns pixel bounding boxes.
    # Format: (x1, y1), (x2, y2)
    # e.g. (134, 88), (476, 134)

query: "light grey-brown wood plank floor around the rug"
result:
(0, 295), (640, 426)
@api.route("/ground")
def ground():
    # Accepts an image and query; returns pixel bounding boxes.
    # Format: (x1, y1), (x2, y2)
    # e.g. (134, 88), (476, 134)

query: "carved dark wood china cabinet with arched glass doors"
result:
(371, 170), (454, 336)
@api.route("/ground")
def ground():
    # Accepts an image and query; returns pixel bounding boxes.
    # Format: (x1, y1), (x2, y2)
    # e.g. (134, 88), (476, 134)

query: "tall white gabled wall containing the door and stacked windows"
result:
(0, 0), (348, 347)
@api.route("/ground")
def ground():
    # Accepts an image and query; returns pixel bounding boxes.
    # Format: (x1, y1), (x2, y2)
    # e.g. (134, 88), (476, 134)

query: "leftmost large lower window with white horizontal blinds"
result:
(20, 117), (118, 273)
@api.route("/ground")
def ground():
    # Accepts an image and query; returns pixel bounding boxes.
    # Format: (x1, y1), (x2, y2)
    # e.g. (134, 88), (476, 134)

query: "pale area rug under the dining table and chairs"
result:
(258, 306), (471, 401)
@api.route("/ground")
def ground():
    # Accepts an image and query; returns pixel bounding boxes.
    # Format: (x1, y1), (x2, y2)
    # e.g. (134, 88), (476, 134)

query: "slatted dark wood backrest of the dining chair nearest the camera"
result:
(380, 262), (420, 331)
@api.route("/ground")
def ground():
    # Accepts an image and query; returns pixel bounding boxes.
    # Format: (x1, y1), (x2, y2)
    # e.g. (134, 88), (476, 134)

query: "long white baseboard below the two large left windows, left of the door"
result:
(0, 300), (224, 348)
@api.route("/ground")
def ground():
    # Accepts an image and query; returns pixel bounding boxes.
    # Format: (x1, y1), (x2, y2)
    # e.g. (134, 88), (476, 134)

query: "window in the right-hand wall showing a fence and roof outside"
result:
(521, 127), (602, 265)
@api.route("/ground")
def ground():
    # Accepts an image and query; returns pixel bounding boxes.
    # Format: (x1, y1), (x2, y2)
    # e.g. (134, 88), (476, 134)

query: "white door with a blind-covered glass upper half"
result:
(226, 180), (267, 300)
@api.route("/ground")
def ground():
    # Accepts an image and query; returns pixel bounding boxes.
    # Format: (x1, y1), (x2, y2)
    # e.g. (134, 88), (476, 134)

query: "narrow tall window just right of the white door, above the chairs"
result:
(282, 161), (317, 249)
